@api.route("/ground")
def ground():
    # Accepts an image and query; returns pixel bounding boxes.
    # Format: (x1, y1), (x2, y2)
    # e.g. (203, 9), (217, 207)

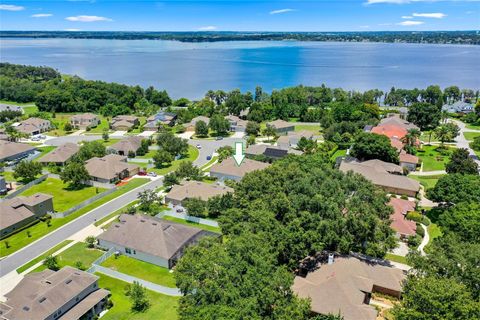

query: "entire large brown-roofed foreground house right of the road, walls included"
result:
(97, 214), (218, 269)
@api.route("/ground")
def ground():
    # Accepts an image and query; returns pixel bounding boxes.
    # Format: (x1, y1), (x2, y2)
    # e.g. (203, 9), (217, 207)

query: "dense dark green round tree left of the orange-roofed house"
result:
(350, 132), (398, 163)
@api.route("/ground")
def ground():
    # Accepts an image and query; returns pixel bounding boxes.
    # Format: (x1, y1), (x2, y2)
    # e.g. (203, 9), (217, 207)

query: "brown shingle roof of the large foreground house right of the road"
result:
(98, 214), (202, 260)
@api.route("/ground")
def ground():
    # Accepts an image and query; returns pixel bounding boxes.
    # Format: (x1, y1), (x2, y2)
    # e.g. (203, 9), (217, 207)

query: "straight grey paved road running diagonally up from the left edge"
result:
(0, 178), (163, 277)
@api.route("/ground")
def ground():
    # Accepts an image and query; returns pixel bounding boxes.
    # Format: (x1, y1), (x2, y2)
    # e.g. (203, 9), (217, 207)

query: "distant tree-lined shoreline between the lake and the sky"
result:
(0, 31), (480, 45)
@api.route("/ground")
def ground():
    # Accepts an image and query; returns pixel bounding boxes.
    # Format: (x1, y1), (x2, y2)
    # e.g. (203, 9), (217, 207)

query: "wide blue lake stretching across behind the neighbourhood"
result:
(0, 39), (480, 99)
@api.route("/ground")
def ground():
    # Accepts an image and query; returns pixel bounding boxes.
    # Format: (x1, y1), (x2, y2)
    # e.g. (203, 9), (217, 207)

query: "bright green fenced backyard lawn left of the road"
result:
(21, 178), (106, 212)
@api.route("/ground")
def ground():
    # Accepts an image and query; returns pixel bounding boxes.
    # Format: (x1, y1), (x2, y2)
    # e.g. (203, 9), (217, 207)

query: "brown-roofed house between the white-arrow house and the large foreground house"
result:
(165, 181), (233, 206)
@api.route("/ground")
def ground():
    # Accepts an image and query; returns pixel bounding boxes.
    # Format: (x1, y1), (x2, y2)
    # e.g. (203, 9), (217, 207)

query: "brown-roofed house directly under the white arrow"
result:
(210, 157), (270, 181)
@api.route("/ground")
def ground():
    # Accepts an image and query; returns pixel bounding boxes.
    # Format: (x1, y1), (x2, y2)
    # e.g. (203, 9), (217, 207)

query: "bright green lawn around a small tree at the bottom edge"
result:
(96, 273), (179, 320)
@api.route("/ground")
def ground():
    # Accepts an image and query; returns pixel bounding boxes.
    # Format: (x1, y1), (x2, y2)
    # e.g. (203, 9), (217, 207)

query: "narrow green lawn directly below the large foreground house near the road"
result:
(102, 255), (175, 288)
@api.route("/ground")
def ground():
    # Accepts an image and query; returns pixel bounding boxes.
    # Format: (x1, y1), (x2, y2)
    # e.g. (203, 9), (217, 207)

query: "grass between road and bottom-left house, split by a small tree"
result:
(32, 242), (105, 272)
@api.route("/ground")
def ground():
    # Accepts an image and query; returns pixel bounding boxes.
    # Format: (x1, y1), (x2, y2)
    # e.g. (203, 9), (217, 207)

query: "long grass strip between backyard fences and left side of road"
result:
(0, 178), (150, 257)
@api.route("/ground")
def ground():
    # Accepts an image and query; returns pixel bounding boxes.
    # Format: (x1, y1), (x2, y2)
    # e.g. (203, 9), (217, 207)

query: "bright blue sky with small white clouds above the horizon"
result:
(0, 0), (480, 31)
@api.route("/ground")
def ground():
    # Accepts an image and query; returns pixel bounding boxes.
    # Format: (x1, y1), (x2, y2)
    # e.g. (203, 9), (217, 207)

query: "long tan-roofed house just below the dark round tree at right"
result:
(340, 160), (420, 197)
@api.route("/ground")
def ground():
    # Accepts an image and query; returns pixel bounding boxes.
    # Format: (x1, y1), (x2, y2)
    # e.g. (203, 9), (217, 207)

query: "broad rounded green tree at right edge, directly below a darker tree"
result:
(427, 173), (480, 203)
